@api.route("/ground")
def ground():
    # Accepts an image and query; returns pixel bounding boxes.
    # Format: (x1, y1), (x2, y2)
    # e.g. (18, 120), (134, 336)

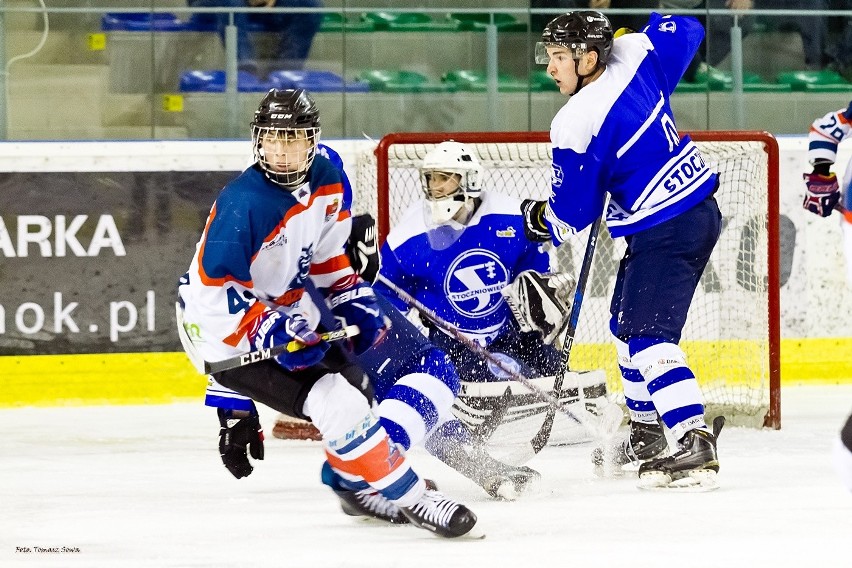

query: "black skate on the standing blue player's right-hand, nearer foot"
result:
(639, 416), (725, 491)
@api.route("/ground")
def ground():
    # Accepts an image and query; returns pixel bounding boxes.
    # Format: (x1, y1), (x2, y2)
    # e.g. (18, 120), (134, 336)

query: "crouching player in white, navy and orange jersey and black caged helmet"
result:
(178, 89), (476, 537)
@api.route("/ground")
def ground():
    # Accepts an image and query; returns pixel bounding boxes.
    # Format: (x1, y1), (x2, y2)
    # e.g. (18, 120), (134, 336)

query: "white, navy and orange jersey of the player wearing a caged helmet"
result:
(178, 155), (354, 361)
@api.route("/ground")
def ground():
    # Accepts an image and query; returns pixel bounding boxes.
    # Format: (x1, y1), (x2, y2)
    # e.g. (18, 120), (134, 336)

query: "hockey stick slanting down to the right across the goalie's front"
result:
(376, 273), (599, 438)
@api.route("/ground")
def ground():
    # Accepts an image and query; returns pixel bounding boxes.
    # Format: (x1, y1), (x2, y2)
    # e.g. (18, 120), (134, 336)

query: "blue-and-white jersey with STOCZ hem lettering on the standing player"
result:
(545, 14), (716, 243)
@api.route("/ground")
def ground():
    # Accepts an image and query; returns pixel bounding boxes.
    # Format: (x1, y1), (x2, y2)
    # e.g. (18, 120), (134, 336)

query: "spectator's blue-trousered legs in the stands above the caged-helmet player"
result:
(187, 0), (322, 75)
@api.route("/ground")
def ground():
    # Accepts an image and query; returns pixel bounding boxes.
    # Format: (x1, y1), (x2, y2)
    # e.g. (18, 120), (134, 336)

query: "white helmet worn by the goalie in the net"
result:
(420, 140), (482, 224)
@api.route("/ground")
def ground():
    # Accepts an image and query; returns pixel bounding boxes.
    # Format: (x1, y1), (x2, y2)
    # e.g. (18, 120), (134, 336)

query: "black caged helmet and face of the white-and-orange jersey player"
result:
(251, 89), (320, 189)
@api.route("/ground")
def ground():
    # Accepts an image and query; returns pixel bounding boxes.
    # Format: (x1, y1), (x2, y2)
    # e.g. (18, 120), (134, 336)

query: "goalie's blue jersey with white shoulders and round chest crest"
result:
(374, 192), (550, 345)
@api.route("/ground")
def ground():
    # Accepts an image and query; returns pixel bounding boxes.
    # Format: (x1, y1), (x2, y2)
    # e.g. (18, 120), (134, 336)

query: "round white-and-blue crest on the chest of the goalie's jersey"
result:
(444, 249), (509, 318)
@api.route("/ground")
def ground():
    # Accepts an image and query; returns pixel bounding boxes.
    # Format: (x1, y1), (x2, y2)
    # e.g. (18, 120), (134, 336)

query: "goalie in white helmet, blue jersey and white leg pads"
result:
(374, 141), (608, 462)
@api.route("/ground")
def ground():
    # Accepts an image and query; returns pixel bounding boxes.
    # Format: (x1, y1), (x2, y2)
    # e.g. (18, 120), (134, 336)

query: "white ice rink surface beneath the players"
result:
(0, 386), (852, 568)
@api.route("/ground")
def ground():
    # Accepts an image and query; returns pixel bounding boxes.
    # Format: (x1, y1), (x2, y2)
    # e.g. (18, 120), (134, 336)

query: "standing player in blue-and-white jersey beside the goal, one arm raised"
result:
(522, 11), (724, 489)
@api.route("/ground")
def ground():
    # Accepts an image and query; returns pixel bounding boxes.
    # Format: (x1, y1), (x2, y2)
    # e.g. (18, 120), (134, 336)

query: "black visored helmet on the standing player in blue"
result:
(535, 10), (613, 65)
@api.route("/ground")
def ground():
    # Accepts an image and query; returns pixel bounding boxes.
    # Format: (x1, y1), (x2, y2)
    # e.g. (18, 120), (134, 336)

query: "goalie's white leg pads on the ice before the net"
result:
(453, 370), (613, 465)
